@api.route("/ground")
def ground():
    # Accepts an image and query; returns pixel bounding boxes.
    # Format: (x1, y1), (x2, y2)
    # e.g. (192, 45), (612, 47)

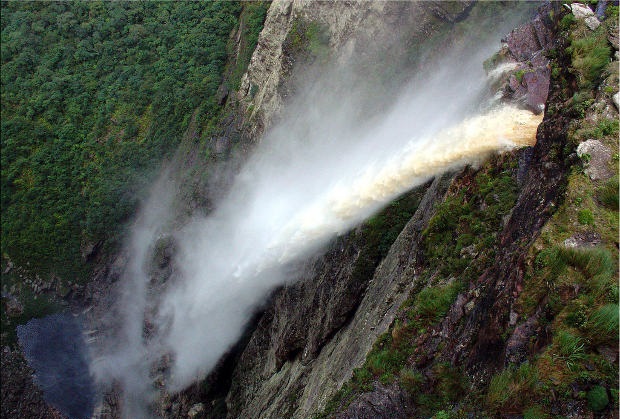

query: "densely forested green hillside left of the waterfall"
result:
(2, 1), (254, 279)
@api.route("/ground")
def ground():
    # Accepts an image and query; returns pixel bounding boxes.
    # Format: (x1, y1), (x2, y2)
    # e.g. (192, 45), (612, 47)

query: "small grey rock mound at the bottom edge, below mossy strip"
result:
(336, 382), (412, 419)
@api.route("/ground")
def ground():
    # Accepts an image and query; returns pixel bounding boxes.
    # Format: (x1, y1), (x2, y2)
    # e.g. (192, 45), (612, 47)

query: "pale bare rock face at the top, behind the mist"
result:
(236, 0), (474, 140)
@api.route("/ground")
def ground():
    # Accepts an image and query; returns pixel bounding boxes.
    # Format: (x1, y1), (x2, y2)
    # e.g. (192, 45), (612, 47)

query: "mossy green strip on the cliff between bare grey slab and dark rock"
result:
(318, 155), (517, 418)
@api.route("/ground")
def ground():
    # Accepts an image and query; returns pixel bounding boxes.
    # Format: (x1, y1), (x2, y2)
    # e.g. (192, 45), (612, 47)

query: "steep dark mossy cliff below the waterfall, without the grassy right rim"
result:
(220, 1), (617, 417)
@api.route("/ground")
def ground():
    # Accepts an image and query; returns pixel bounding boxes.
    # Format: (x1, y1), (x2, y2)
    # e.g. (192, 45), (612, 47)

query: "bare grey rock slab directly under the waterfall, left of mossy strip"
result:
(227, 179), (448, 418)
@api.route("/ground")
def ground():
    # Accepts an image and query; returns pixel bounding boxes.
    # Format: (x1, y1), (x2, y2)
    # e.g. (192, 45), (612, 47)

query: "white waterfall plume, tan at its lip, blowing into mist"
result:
(93, 22), (542, 417)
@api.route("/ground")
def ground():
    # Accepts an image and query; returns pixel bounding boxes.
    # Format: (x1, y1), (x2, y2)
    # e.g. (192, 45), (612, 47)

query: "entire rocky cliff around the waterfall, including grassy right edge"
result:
(3, 0), (618, 418)
